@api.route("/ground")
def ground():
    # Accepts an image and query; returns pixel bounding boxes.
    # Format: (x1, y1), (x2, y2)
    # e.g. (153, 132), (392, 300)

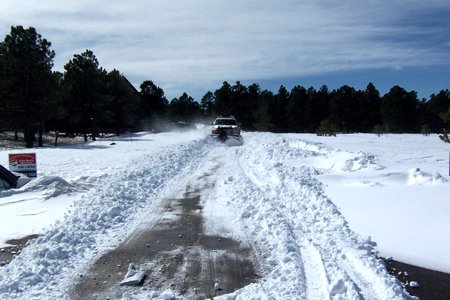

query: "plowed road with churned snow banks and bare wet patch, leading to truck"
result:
(0, 133), (416, 299)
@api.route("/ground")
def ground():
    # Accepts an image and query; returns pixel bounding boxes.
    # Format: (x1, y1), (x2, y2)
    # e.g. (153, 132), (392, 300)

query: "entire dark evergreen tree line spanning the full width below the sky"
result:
(0, 26), (450, 147)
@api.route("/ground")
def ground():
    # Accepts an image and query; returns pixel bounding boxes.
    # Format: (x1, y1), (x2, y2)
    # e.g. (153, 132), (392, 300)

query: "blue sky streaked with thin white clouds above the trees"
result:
(0, 0), (450, 100)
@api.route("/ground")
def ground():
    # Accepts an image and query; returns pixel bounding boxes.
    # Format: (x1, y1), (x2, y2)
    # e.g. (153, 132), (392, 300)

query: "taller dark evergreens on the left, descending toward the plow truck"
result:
(0, 26), (196, 147)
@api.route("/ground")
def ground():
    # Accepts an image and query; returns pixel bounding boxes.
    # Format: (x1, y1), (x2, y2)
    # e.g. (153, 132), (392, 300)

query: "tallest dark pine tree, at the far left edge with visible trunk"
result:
(0, 26), (55, 148)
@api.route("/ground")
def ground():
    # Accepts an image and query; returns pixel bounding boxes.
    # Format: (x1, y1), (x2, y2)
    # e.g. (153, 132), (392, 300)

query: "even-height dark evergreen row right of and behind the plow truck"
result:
(206, 82), (450, 134)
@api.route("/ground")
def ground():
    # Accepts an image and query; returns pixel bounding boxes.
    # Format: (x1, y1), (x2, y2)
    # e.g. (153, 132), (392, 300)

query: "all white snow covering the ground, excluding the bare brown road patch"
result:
(0, 129), (450, 299)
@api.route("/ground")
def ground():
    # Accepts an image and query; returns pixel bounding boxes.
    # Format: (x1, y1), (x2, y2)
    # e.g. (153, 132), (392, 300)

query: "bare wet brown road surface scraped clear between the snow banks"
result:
(70, 187), (259, 299)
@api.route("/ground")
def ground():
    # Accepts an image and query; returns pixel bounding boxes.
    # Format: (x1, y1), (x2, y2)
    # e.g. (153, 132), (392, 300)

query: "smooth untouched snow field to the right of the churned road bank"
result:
(290, 134), (450, 273)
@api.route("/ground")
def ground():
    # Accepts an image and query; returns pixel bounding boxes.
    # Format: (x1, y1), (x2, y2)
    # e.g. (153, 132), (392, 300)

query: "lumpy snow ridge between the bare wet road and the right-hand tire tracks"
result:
(215, 149), (305, 299)
